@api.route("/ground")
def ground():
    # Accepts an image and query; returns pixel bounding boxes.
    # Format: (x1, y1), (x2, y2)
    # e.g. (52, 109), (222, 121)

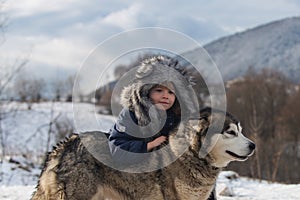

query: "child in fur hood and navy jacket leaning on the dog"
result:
(109, 56), (194, 164)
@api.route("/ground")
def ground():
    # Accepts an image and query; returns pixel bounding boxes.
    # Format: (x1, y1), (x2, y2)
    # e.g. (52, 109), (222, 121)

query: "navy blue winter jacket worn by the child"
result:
(109, 108), (180, 162)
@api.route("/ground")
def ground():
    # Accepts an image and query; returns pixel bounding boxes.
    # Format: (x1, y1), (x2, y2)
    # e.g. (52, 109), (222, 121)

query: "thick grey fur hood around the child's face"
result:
(121, 55), (199, 126)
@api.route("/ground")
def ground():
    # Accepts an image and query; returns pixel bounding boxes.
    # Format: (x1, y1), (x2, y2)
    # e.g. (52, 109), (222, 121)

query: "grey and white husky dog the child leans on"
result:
(32, 108), (255, 200)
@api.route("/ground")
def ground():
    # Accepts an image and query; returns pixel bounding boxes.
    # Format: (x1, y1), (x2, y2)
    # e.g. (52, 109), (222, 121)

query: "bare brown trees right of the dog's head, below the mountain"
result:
(227, 68), (300, 183)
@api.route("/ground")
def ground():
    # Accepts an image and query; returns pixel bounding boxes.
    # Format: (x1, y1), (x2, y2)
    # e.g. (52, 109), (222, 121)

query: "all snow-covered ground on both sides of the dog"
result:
(0, 103), (300, 200)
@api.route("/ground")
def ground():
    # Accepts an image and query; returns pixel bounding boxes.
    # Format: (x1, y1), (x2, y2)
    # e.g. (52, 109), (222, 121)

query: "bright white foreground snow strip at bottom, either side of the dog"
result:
(0, 172), (300, 200)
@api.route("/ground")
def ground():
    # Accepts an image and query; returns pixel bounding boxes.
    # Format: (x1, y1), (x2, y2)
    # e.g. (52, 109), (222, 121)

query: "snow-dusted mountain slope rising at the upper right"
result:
(186, 17), (300, 83)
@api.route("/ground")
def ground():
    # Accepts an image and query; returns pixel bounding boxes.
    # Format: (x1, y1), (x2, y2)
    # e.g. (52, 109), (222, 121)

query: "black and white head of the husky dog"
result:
(191, 108), (255, 167)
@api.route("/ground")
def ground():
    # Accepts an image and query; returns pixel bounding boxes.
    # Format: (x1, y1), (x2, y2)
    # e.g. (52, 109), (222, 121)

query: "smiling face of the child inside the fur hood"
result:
(149, 85), (176, 110)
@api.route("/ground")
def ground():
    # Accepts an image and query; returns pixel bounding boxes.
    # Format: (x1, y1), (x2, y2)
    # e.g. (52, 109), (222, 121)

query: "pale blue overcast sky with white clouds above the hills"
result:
(0, 0), (300, 92)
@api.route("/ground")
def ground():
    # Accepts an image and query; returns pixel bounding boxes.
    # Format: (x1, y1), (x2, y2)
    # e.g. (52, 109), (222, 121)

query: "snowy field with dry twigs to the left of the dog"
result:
(0, 102), (115, 186)
